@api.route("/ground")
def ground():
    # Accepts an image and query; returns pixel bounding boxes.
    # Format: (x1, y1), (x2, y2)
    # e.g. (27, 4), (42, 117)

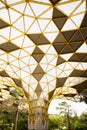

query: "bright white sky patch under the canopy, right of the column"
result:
(48, 99), (87, 116)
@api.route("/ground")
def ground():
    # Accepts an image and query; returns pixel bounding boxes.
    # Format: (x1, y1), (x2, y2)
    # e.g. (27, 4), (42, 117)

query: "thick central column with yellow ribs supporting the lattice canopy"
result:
(28, 100), (48, 130)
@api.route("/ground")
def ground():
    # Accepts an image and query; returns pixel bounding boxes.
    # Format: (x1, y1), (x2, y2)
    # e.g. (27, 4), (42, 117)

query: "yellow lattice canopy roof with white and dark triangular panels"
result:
(0, 0), (87, 111)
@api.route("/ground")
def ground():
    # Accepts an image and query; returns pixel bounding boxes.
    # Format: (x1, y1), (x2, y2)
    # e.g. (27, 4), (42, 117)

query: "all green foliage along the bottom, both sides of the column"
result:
(0, 109), (87, 130)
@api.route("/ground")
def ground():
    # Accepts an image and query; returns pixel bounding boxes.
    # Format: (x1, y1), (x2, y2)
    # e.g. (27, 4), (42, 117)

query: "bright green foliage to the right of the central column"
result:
(49, 112), (87, 130)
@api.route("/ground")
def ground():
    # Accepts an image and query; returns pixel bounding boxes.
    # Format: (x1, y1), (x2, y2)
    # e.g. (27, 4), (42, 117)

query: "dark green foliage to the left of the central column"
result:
(0, 112), (28, 130)
